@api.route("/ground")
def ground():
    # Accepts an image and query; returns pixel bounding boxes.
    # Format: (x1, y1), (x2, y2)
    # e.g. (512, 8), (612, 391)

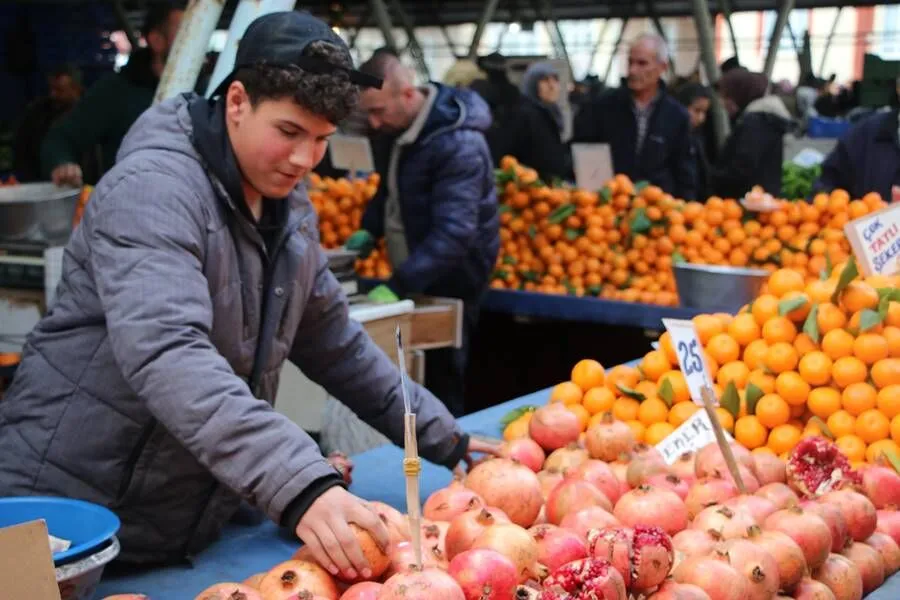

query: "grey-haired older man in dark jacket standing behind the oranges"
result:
(572, 35), (697, 200)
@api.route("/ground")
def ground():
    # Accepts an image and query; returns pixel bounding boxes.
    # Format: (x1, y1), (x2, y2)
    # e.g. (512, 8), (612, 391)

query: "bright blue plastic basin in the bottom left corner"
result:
(0, 496), (121, 566)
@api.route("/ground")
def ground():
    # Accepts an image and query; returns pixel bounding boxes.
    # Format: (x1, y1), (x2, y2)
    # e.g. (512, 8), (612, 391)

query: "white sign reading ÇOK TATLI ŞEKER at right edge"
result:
(844, 204), (900, 275)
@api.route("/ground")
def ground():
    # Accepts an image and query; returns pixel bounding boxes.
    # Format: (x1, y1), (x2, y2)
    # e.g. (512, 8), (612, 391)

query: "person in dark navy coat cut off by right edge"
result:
(813, 109), (900, 202)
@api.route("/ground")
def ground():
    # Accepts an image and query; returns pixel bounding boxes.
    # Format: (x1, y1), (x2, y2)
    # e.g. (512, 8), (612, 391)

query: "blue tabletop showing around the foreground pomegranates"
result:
(96, 389), (900, 600)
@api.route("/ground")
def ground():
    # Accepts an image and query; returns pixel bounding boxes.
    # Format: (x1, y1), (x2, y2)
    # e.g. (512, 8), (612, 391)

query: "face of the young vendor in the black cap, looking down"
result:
(226, 83), (336, 198)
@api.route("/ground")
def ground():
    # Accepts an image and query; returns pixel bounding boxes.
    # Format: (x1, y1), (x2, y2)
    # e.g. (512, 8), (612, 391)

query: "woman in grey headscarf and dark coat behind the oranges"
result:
(509, 62), (574, 183)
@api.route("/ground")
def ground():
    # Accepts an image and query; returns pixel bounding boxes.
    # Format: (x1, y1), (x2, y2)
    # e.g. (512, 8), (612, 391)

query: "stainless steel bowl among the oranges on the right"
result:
(673, 263), (769, 313)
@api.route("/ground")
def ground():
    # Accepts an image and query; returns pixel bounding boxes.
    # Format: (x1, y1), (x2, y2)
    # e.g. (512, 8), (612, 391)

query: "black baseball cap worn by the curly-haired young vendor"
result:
(212, 10), (382, 97)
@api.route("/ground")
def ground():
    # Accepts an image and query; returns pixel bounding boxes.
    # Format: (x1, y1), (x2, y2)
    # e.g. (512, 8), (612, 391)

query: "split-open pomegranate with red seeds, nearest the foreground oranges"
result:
(787, 436), (861, 498)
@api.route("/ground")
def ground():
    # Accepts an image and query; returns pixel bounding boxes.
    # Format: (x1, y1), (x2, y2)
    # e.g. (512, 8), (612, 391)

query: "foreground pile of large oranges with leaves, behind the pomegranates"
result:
(508, 259), (900, 463)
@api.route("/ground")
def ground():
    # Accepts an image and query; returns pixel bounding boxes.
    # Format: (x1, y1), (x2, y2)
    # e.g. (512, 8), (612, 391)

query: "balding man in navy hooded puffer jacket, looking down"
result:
(347, 56), (500, 416)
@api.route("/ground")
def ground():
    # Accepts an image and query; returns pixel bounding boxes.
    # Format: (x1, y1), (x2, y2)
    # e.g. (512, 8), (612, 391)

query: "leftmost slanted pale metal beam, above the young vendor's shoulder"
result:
(153, 0), (225, 104)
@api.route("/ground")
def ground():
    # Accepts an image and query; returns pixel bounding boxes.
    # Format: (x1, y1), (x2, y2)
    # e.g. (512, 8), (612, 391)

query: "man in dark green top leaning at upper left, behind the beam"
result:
(41, 3), (184, 186)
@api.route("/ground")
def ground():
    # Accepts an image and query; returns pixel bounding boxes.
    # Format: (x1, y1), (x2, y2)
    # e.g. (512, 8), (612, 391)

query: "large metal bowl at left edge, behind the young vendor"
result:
(0, 183), (81, 244)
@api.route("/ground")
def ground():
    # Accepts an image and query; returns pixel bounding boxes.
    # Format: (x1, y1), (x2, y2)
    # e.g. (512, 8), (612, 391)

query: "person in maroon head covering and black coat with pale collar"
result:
(710, 69), (793, 198)
